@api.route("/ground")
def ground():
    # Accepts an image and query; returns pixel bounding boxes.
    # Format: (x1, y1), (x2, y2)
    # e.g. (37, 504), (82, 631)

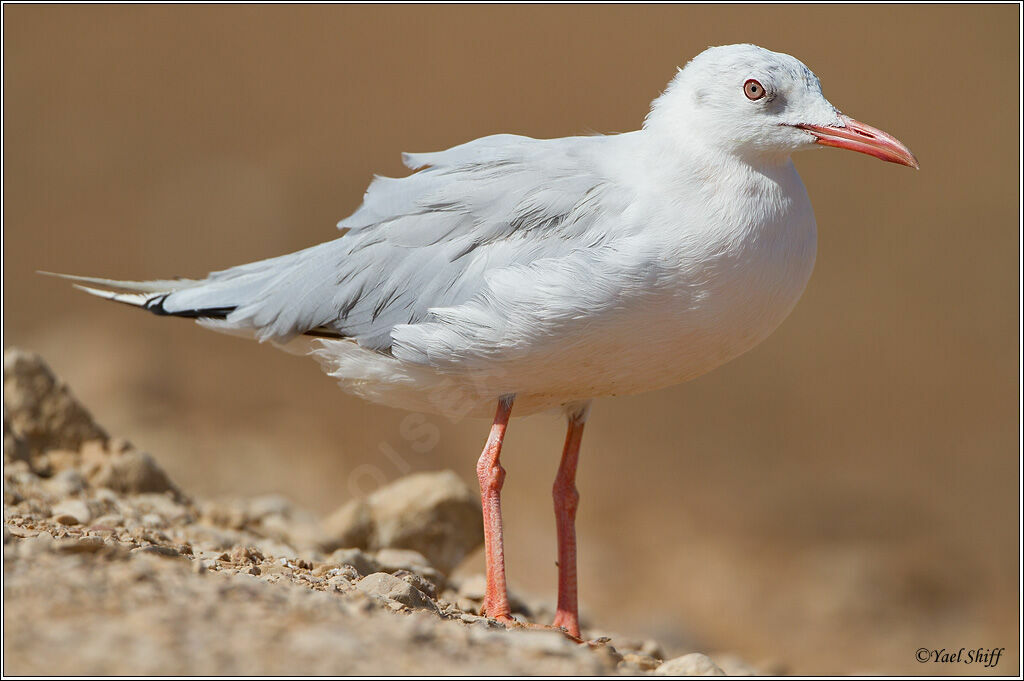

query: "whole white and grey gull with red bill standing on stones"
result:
(49, 45), (919, 639)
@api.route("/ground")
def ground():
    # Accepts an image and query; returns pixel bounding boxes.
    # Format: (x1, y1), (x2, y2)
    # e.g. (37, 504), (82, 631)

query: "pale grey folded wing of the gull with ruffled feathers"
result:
(162, 135), (628, 350)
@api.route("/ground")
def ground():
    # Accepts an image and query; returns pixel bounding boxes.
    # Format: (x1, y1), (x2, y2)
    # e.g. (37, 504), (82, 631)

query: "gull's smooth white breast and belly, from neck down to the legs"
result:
(503, 156), (816, 403)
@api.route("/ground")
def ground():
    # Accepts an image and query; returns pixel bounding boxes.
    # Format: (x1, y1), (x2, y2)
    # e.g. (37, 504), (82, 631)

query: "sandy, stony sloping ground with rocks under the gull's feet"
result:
(3, 350), (765, 675)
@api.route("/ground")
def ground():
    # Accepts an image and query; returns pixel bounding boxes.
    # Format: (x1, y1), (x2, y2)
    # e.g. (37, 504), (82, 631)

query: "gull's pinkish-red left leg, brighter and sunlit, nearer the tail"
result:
(476, 395), (515, 623)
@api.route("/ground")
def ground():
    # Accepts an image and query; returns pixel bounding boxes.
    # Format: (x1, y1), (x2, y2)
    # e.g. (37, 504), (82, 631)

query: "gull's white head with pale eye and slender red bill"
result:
(644, 45), (919, 168)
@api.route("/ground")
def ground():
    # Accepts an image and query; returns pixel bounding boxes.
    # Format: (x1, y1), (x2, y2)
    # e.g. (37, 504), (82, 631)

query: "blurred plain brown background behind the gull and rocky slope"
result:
(3, 5), (1020, 674)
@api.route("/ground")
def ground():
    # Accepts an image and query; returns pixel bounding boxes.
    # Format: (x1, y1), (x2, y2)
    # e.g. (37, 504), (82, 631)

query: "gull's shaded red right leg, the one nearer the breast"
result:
(551, 402), (590, 638)
